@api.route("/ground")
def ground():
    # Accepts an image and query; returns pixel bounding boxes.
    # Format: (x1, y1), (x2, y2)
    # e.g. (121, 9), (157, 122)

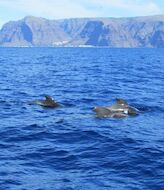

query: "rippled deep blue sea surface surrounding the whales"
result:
(0, 48), (164, 190)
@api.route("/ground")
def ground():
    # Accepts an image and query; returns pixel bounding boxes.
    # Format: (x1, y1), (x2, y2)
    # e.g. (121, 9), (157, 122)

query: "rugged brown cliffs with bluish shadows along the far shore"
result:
(0, 15), (164, 48)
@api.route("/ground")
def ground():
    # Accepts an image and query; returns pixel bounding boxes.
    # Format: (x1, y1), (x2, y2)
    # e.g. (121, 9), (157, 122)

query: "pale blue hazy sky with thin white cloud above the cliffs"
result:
(0, 0), (164, 27)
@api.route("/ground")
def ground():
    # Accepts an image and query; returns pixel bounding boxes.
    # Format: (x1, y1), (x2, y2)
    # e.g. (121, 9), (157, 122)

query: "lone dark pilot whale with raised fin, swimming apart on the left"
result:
(29, 95), (60, 108)
